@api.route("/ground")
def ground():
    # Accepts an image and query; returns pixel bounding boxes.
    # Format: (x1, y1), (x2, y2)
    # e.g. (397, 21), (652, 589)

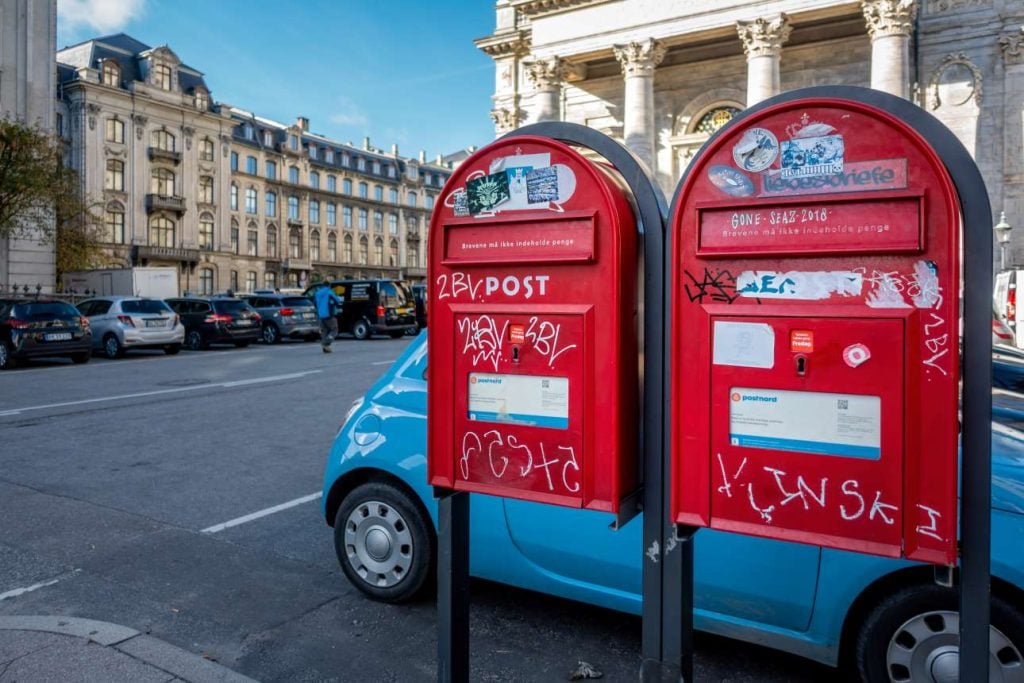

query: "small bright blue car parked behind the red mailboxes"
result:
(323, 335), (1024, 682)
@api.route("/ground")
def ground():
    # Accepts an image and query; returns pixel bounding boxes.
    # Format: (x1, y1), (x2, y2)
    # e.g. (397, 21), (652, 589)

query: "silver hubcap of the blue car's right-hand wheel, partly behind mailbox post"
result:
(886, 610), (1024, 683)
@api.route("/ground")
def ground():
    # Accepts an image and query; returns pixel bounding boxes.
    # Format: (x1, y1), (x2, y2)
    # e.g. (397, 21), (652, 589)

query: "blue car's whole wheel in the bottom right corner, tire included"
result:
(855, 585), (1024, 683)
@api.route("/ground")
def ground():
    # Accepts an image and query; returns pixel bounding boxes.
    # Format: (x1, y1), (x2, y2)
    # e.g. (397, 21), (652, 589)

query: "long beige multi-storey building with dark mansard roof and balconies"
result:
(57, 34), (451, 294)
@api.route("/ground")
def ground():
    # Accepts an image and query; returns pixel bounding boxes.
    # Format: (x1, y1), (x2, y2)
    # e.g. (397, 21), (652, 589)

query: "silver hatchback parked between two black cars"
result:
(78, 296), (185, 358)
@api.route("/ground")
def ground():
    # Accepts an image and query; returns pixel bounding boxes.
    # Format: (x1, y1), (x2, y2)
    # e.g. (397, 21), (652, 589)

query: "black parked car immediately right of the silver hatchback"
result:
(166, 297), (260, 350)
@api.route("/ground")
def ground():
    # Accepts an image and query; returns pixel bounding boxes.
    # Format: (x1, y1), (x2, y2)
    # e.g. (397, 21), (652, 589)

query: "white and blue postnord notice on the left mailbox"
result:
(469, 373), (569, 429)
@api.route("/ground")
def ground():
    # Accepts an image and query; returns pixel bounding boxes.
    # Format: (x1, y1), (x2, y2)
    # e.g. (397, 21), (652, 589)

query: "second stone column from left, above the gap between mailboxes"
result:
(613, 38), (667, 171)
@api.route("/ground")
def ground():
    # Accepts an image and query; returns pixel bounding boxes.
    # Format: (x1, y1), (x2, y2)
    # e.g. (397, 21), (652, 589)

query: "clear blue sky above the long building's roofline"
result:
(57, 0), (495, 158)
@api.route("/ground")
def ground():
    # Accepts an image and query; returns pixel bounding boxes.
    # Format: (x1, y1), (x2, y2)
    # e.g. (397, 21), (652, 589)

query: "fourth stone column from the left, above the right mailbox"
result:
(860, 0), (918, 98)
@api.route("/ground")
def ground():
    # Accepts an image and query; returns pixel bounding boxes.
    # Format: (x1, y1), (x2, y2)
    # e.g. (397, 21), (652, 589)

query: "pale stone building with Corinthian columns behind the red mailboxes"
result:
(476, 0), (1024, 264)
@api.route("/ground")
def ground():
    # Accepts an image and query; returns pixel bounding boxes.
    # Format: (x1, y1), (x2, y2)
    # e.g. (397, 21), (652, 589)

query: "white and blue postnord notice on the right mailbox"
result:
(729, 387), (882, 460)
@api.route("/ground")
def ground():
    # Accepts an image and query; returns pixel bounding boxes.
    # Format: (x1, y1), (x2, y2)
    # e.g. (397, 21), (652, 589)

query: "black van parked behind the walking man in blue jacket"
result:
(304, 280), (416, 339)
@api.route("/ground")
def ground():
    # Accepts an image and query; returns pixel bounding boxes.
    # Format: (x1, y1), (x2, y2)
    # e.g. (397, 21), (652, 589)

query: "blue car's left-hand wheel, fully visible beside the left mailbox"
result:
(334, 481), (436, 602)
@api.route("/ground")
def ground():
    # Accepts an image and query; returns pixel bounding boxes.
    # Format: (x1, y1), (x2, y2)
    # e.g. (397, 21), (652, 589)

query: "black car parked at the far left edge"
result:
(0, 299), (92, 369)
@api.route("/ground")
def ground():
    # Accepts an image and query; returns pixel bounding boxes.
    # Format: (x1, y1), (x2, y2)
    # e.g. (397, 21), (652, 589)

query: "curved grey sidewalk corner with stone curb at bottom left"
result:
(0, 616), (253, 683)
